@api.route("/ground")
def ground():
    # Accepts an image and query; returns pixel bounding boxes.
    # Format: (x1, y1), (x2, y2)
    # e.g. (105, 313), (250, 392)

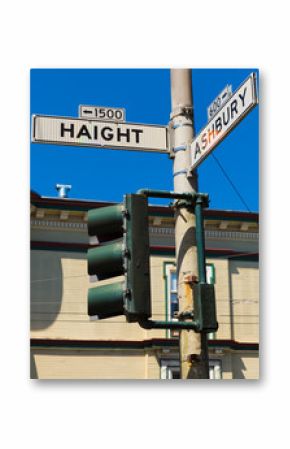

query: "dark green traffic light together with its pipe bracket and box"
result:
(88, 189), (218, 332)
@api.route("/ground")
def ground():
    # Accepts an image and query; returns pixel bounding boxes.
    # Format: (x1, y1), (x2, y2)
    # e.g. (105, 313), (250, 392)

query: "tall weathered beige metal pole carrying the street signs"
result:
(170, 69), (209, 379)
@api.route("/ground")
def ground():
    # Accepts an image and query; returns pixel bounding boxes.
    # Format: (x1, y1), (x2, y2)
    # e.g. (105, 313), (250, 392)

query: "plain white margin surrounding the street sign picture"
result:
(0, 0), (284, 449)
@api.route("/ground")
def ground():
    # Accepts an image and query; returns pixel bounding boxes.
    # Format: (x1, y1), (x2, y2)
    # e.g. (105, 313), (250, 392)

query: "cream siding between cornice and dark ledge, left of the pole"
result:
(30, 250), (169, 340)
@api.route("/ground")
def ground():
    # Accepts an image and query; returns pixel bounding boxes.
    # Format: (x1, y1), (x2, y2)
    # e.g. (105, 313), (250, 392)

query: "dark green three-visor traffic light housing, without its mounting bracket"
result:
(88, 194), (151, 322)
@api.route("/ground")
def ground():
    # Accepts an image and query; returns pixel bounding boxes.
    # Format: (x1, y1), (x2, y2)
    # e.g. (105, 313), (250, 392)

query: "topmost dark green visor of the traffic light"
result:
(88, 204), (124, 242)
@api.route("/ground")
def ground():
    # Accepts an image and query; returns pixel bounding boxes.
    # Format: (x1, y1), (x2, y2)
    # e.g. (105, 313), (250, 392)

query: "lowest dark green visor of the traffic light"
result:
(88, 282), (125, 319)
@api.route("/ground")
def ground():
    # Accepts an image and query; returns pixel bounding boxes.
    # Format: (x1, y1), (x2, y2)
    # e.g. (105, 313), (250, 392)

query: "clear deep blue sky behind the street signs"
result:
(30, 69), (259, 212)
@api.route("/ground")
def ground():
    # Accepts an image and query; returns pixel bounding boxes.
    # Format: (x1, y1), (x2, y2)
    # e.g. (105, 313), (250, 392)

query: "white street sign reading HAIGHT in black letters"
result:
(32, 115), (169, 153)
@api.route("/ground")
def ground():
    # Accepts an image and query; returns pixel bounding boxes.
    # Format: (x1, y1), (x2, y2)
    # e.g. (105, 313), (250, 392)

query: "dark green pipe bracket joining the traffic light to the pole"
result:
(137, 189), (217, 332)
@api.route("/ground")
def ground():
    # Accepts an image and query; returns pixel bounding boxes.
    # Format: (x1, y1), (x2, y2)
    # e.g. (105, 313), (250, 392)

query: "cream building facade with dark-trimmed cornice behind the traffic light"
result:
(30, 189), (259, 380)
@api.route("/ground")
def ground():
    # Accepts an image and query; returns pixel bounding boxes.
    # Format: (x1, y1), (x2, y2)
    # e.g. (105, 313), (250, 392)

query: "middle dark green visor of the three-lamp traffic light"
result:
(88, 240), (124, 280)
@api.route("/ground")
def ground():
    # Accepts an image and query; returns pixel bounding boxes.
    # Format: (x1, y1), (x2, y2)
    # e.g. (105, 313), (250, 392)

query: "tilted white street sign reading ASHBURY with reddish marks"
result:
(189, 73), (258, 172)
